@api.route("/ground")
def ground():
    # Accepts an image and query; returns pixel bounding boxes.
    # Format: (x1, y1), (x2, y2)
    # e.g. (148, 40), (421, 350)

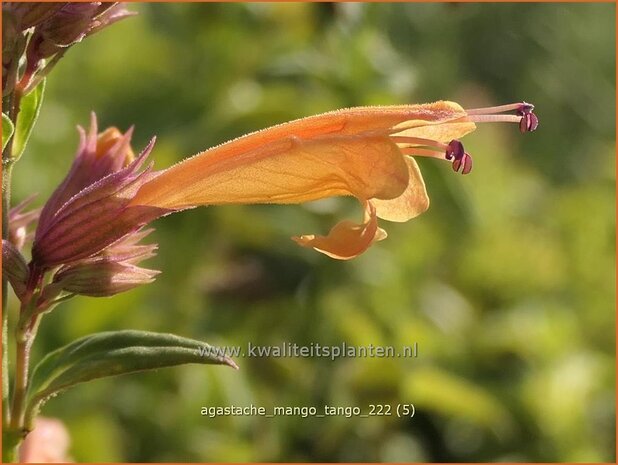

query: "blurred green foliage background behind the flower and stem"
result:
(7, 3), (616, 462)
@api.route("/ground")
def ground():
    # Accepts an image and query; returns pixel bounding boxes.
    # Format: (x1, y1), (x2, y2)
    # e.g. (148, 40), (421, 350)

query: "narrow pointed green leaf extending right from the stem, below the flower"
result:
(28, 330), (238, 417)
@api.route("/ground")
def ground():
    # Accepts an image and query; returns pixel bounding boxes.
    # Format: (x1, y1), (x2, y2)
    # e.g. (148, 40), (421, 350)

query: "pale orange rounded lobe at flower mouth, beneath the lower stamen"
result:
(371, 157), (429, 223)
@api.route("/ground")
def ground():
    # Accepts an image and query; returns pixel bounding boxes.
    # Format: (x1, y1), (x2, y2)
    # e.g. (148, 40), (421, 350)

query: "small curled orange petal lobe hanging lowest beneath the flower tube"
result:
(292, 202), (386, 260)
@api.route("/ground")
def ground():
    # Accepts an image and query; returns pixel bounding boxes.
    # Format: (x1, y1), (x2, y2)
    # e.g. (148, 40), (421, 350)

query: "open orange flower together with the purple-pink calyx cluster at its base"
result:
(30, 102), (538, 300)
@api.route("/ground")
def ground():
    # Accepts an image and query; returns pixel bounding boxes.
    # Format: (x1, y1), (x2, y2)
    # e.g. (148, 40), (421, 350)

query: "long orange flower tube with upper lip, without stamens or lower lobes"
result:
(131, 102), (466, 209)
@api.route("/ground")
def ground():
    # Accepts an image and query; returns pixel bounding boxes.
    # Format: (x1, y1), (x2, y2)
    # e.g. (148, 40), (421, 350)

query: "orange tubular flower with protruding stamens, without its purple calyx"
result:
(130, 101), (538, 260)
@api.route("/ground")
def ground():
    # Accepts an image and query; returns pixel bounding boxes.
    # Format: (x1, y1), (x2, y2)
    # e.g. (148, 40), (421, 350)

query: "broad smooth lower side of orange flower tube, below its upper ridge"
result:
(132, 135), (408, 208)
